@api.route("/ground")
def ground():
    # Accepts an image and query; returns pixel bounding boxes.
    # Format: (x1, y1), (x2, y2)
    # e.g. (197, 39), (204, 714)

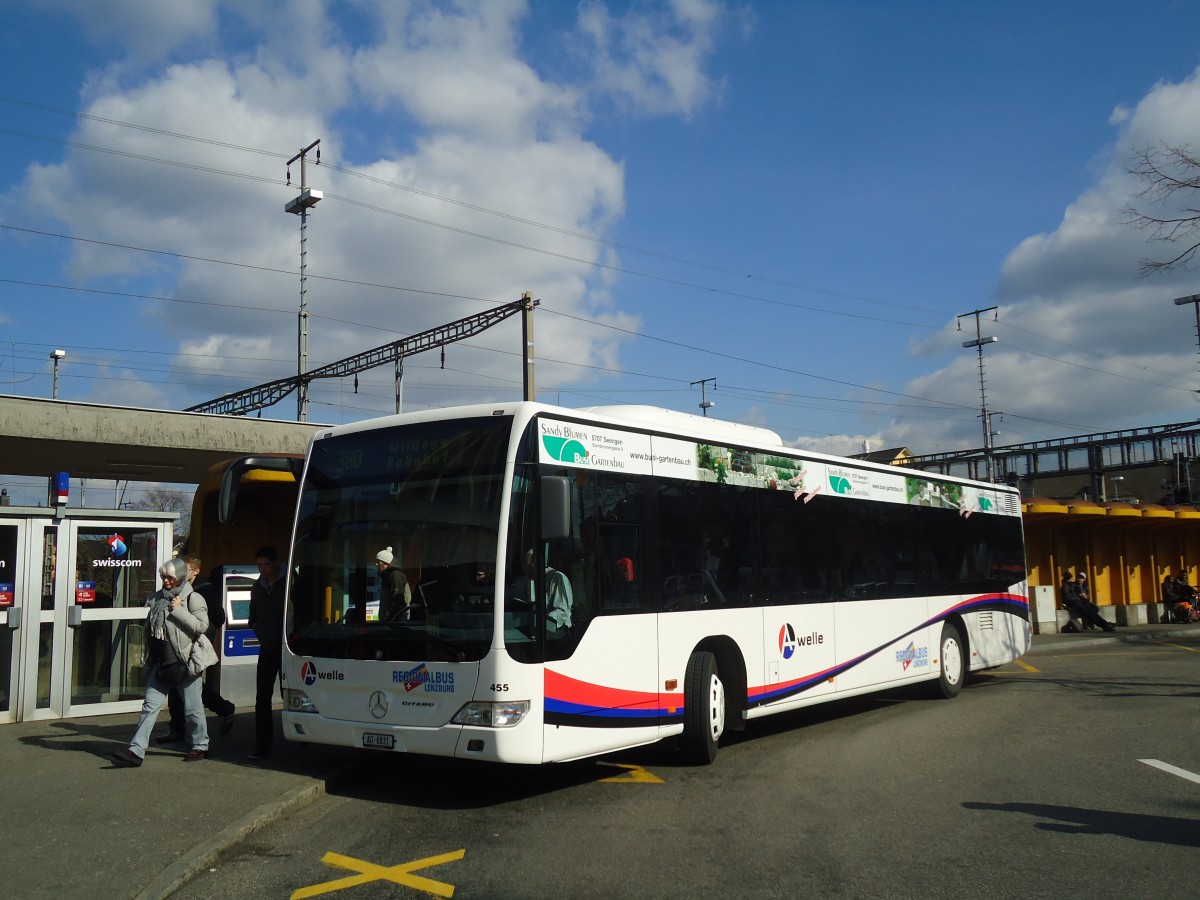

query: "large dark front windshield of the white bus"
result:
(287, 416), (512, 661)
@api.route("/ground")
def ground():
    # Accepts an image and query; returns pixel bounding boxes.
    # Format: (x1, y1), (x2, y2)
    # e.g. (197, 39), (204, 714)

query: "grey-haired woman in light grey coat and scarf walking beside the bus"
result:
(113, 557), (209, 766)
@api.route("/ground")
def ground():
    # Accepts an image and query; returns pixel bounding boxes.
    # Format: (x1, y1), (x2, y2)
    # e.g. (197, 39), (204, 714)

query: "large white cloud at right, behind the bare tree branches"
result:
(884, 68), (1200, 454)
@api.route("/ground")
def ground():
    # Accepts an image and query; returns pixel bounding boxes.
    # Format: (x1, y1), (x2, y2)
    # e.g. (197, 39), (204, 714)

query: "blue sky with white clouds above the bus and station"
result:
(0, 0), (1200, 504)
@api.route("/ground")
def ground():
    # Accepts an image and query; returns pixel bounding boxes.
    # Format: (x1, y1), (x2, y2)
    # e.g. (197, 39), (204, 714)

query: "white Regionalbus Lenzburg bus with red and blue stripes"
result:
(274, 403), (1030, 763)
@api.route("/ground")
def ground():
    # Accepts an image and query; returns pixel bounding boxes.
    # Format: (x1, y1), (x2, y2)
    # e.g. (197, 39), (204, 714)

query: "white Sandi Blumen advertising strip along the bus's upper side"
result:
(538, 418), (1019, 516)
